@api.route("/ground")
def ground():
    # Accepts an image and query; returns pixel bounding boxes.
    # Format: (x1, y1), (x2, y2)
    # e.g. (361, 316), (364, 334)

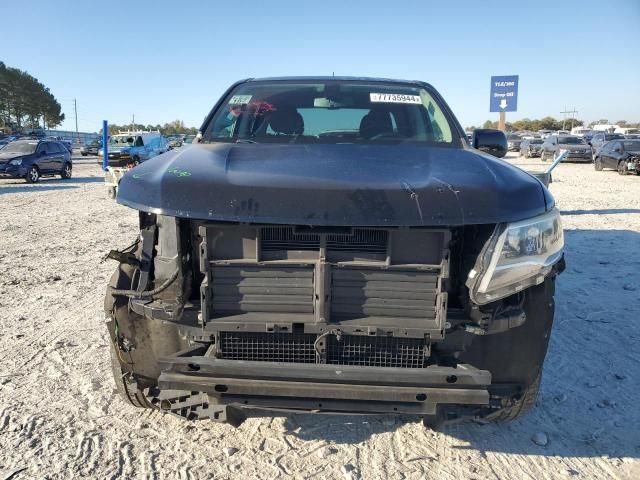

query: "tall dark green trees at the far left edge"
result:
(0, 62), (64, 131)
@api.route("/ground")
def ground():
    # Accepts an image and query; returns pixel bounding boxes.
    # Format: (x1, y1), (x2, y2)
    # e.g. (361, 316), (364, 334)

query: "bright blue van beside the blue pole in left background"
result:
(98, 132), (169, 167)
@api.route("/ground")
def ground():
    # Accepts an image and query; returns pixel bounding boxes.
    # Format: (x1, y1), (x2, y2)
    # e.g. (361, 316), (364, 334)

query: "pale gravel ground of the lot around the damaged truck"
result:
(0, 156), (640, 480)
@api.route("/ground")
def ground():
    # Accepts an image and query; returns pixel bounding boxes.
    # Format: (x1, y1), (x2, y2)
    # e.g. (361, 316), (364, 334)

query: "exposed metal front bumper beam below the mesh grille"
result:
(150, 356), (491, 420)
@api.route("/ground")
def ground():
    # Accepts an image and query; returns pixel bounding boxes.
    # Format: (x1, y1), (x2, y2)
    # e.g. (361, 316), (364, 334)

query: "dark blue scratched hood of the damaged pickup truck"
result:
(118, 143), (553, 226)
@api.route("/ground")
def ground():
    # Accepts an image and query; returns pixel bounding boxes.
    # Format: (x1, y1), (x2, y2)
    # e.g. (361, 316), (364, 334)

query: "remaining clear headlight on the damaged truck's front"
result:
(466, 208), (564, 305)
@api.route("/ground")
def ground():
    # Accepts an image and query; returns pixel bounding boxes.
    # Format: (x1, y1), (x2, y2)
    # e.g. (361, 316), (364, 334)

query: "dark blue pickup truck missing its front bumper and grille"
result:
(105, 77), (564, 427)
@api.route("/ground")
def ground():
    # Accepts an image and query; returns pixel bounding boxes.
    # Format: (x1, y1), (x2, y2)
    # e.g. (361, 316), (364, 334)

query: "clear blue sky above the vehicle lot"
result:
(0, 0), (640, 131)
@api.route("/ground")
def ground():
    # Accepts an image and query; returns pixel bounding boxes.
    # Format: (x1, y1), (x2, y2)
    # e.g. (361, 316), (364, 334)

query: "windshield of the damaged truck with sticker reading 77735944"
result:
(203, 81), (460, 146)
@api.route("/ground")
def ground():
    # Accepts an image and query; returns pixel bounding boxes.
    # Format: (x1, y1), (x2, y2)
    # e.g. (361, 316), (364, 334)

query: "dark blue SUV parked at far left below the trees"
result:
(0, 140), (73, 183)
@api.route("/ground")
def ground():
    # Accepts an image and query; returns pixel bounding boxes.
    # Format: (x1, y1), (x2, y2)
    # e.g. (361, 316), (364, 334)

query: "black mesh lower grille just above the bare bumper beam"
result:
(219, 332), (428, 368)
